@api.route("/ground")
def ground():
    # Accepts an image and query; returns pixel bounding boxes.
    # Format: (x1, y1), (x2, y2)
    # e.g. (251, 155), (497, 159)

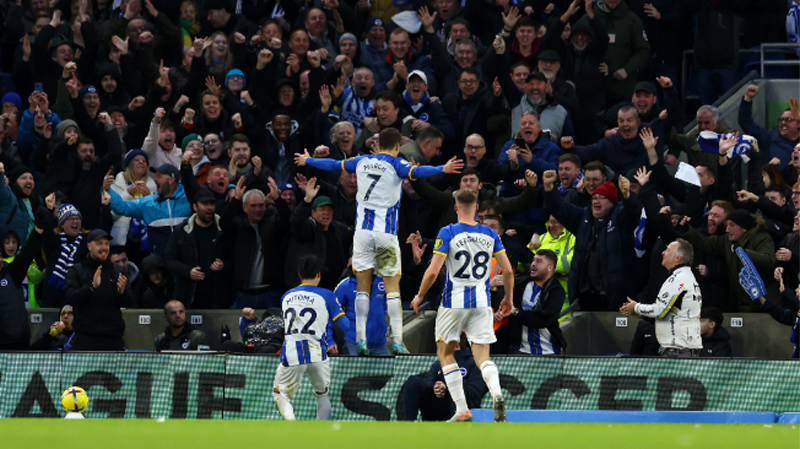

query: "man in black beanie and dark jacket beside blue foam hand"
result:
(681, 209), (780, 312)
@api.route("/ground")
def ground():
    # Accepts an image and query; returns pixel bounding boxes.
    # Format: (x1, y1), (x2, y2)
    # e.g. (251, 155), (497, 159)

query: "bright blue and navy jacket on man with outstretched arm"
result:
(108, 184), (192, 255)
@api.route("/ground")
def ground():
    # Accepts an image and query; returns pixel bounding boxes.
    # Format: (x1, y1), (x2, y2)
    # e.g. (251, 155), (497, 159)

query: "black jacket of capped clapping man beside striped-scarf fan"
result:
(65, 254), (133, 338)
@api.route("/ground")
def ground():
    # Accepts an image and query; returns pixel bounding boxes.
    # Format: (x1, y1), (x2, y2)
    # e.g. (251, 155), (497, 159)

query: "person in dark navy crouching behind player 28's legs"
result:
(403, 335), (487, 421)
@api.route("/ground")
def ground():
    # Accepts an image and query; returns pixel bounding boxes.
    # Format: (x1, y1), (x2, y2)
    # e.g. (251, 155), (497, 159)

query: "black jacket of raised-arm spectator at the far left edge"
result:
(0, 226), (42, 345)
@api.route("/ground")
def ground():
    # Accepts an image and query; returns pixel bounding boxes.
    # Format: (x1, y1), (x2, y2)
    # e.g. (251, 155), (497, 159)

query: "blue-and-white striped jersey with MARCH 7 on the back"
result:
(356, 153), (413, 235)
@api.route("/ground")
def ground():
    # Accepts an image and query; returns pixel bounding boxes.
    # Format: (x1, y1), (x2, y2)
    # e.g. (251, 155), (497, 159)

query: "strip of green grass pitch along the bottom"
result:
(0, 419), (800, 449)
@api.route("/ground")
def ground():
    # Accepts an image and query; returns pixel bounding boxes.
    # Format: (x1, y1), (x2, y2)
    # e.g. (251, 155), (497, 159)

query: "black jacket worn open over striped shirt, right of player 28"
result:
(508, 273), (567, 351)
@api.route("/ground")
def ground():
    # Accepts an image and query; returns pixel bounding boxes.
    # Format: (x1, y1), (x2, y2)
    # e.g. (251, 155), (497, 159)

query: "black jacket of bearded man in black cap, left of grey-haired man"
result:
(164, 214), (230, 309)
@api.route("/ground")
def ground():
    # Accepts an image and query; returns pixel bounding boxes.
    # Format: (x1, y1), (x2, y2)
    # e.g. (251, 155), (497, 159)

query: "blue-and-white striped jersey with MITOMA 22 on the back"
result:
(281, 285), (344, 366)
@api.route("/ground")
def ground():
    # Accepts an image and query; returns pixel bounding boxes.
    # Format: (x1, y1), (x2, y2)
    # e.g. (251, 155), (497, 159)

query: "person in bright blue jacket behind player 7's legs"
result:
(327, 268), (391, 356)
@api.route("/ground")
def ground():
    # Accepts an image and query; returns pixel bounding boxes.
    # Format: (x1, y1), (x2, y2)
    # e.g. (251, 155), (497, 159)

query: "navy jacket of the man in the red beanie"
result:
(544, 188), (642, 310)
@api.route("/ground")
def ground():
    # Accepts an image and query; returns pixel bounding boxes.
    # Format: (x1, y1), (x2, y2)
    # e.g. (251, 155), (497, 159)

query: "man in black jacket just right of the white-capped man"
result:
(442, 68), (503, 158)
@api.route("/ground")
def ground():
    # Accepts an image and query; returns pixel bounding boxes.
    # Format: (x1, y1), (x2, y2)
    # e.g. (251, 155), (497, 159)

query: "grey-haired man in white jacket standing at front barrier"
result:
(619, 239), (703, 358)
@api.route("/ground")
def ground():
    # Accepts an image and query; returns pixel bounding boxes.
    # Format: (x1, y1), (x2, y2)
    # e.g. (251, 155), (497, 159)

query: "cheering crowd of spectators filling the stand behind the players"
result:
(0, 0), (800, 352)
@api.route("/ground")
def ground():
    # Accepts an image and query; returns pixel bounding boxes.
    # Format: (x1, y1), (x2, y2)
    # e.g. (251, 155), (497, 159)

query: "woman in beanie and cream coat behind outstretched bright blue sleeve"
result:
(111, 149), (158, 250)
